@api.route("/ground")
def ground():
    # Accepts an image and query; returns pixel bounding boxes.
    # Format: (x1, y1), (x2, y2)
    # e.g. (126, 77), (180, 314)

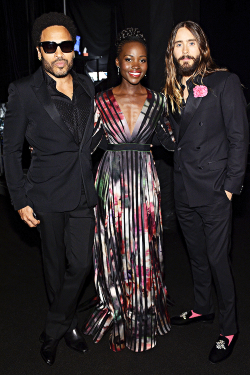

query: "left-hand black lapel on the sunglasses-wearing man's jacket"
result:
(32, 68), (74, 139)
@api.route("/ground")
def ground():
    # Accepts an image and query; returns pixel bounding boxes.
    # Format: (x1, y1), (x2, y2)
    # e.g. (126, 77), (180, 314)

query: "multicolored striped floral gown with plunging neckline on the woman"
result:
(84, 90), (172, 352)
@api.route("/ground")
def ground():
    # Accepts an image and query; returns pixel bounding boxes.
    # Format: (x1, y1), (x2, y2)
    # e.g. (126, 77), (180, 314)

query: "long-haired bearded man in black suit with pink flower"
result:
(165, 21), (248, 363)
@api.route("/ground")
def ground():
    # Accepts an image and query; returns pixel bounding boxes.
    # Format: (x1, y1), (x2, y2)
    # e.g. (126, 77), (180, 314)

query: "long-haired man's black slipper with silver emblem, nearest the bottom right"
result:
(209, 334), (238, 364)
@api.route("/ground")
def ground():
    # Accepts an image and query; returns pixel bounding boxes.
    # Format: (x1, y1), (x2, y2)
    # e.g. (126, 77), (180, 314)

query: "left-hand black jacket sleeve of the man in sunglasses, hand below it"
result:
(3, 83), (30, 210)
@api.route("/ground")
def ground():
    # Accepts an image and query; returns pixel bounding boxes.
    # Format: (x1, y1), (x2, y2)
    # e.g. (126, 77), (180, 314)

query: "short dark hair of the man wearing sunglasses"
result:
(32, 12), (76, 46)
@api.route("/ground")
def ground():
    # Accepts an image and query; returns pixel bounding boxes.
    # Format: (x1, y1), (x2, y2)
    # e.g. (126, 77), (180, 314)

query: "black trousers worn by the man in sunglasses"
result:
(36, 195), (94, 339)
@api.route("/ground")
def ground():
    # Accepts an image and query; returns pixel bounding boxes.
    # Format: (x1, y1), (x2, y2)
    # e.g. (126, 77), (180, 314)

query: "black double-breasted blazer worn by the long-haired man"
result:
(170, 71), (249, 207)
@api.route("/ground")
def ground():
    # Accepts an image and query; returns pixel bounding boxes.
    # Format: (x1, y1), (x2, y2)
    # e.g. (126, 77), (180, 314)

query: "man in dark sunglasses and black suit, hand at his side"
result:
(4, 13), (96, 365)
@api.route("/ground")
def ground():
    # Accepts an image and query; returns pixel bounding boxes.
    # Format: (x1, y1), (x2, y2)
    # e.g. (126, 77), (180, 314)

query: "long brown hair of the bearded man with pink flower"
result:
(163, 21), (227, 112)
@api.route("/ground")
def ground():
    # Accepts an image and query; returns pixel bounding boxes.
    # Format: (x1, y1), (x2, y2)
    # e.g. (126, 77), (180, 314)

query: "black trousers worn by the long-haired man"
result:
(176, 192), (237, 336)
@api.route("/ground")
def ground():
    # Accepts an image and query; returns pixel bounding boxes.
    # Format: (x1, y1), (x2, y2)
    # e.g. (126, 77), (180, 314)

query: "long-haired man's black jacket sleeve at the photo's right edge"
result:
(221, 74), (249, 194)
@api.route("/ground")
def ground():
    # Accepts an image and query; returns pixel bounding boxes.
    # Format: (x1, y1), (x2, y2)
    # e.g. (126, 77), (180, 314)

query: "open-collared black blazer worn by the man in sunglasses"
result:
(4, 68), (97, 212)
